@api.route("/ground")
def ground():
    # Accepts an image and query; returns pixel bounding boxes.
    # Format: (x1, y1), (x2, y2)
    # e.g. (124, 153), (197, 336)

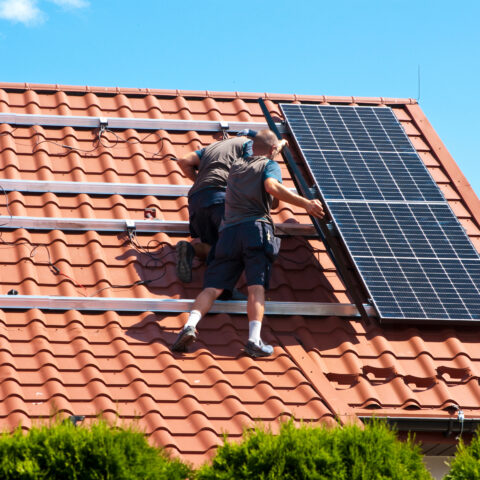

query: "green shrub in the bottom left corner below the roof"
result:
(0, 420), (191, 480)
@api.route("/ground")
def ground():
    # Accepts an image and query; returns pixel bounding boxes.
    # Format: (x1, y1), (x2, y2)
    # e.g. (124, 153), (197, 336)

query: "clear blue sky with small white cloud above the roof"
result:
(0, 0), (480, 195)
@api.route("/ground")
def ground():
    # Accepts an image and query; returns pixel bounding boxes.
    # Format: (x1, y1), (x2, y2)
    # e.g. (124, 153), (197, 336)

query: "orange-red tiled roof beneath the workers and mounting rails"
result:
(0, 84), (480, 464)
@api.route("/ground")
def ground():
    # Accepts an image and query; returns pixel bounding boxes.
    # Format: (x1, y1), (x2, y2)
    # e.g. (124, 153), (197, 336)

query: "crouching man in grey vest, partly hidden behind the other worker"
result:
(176, 129), (256, 283)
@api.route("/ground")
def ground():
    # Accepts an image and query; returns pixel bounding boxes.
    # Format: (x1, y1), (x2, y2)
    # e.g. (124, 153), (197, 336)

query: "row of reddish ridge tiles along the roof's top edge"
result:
(0, 82), (417, 105)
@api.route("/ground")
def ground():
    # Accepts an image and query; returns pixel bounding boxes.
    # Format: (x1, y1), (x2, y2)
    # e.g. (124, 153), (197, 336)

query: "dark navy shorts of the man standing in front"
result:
(203, 221), (280, 290)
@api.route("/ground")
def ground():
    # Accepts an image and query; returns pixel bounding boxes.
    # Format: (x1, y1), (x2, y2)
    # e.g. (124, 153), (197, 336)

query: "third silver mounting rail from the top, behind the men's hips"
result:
(0, 215), (317, 237)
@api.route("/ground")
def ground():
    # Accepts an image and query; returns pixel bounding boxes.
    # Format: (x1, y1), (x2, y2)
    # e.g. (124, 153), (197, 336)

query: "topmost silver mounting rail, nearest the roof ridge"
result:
(0, 113), (286, 132)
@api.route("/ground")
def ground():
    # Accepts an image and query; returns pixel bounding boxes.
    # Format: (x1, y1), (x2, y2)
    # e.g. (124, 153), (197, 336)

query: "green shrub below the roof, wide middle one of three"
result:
(197, 421), (432, 480)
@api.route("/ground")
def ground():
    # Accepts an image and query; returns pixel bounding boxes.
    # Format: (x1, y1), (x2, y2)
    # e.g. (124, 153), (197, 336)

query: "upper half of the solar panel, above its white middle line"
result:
(282, 105), (444, 202)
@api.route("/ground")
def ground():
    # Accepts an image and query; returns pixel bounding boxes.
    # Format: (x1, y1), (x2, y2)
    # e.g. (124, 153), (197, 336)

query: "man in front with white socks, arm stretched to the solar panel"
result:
(172, 130), (324, 357)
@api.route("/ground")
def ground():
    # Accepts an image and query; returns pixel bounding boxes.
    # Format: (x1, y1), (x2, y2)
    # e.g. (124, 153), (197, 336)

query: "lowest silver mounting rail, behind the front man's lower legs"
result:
(0, 295), (374, 317)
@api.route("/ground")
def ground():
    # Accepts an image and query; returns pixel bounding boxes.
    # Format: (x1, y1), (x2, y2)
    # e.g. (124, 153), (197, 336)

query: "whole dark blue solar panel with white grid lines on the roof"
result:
(281, 104), (480, 321)
